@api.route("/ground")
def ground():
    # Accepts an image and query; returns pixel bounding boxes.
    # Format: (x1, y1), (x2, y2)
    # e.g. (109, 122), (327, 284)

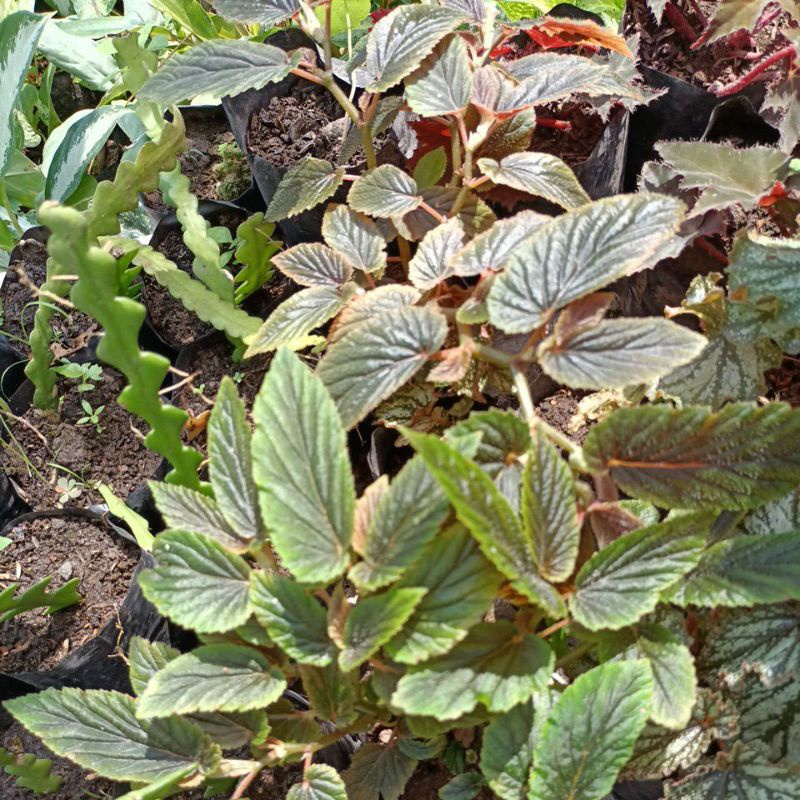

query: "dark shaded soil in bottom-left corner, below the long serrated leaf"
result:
(0, 722), (117, 800)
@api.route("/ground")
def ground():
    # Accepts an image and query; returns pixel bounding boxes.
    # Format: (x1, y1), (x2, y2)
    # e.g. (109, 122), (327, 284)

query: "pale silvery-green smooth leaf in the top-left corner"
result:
(0, 11), (47, 178)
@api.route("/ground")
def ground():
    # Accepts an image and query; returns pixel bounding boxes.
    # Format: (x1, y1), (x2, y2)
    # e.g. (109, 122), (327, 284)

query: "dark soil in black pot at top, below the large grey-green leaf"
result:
(247, 84), (399, 170)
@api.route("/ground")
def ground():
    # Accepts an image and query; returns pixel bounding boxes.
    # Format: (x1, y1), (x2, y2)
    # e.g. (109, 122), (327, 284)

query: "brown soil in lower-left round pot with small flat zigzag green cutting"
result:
(0, 517), (139, 676)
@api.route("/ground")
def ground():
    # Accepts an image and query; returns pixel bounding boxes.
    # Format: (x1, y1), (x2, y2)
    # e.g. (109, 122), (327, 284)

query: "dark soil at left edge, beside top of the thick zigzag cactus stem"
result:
(1, 239), (97, 356)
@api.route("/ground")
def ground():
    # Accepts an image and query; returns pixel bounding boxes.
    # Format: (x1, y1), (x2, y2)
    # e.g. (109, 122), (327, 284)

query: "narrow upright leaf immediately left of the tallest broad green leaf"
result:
(208, 375), (262, 541)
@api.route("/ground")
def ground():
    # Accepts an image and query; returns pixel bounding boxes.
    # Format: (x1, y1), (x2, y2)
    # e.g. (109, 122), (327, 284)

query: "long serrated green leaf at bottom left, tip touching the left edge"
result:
(5, 689), (214, 783)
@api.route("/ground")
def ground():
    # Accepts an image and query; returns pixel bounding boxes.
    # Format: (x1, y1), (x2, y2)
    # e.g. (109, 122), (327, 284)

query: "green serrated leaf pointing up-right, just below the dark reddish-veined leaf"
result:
(569, 512), (714, 631)
